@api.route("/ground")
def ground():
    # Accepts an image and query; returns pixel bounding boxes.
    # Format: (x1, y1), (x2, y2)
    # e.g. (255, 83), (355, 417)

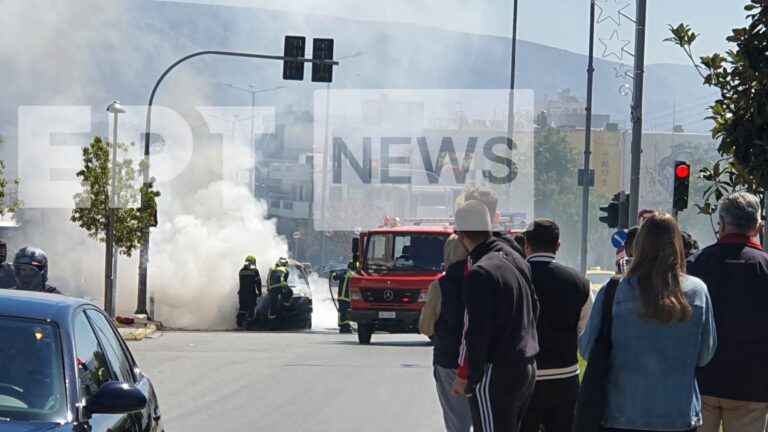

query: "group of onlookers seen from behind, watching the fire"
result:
(420, 188), (768, 432)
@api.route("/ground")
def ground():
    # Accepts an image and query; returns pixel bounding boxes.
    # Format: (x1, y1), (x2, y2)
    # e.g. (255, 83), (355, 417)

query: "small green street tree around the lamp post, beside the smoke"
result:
(70, 137), (160, 256)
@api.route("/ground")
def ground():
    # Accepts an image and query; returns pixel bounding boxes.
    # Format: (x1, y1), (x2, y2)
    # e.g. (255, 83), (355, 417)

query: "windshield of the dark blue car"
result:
(0, 317), (67, 423)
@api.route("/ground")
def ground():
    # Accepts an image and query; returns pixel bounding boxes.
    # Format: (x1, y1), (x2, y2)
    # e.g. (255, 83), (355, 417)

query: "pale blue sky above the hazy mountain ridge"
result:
(157, 0), (746, 64)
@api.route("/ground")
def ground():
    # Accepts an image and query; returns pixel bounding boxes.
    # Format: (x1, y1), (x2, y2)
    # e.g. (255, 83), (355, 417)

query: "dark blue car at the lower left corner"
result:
(0, 290), (163, 432)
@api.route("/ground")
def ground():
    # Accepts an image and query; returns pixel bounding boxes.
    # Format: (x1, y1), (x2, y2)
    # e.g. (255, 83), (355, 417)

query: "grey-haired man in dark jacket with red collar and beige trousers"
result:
(687, 192), (768, 432)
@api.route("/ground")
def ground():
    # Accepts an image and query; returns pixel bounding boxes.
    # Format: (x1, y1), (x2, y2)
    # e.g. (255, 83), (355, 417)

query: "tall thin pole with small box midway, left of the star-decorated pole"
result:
(581, 0), (595, 274)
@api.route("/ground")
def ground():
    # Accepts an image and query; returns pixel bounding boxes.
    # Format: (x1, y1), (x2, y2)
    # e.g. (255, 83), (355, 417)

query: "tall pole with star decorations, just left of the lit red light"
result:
(629, 0), (647, 221)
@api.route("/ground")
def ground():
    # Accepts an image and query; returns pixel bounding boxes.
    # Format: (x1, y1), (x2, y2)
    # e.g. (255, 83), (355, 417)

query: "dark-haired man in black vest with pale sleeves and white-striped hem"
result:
(521, 219), (593, 432)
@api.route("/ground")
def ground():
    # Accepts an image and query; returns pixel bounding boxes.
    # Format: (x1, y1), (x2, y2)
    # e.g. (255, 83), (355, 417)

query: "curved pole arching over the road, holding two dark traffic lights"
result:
(135, 51), (339, 314)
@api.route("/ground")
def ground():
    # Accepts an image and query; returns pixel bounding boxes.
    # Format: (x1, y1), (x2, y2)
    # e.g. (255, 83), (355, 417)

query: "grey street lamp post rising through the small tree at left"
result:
(104, 101), (125, 317)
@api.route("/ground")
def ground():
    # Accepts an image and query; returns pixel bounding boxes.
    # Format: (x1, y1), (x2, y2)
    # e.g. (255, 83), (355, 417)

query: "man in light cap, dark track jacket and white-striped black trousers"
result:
(454, 201), (539, 432)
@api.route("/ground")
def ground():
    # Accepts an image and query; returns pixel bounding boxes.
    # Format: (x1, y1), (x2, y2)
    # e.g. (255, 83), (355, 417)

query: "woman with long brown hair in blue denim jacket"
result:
(579, 213), (717, 431)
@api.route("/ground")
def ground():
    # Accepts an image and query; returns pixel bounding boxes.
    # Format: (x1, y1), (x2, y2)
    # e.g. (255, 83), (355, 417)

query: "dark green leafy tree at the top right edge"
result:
(667, 0), (768, 240)
